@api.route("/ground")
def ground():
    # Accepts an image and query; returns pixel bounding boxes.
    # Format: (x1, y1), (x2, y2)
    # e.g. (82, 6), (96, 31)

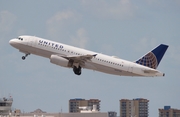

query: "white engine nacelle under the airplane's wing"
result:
(50, 55), (71, 67)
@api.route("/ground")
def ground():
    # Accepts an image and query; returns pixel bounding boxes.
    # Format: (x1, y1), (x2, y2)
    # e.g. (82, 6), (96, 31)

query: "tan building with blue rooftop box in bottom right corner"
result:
(159, 106), (180, 117)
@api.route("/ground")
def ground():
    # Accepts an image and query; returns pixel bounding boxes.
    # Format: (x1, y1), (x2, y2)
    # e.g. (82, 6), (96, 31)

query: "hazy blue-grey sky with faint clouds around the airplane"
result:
(0, 0), (180, 117)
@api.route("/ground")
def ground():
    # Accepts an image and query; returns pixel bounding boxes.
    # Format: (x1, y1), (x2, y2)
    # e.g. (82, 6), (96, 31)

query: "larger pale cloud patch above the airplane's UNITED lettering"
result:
(47, 10), (81, 39)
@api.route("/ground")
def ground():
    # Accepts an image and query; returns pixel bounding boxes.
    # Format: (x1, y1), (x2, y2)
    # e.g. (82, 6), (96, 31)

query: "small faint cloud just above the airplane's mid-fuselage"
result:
(71, 28), (88, 48)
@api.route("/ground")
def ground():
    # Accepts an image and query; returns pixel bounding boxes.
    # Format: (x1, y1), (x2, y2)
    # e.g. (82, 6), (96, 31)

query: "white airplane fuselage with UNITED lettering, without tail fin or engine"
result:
(10, 36), (164, 77)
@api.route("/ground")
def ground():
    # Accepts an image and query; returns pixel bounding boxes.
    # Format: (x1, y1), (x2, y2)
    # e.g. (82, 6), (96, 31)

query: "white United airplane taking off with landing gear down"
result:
(9, 35), (168, 77)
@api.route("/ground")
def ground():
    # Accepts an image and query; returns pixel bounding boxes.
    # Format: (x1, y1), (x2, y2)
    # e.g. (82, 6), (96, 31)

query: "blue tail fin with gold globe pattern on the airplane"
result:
(136, 44), (168, 69)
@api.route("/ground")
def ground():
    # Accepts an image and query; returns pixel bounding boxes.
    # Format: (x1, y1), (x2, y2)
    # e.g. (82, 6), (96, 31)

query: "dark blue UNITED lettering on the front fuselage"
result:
(39, 40), (63, 49)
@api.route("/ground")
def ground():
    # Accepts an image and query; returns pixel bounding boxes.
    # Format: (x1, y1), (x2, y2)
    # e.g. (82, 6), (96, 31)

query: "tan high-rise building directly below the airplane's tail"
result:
(120, 98), (149, 117)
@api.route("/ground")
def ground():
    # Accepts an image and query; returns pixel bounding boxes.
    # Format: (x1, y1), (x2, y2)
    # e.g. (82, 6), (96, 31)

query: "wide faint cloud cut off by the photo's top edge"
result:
(81, 0), (136, 19)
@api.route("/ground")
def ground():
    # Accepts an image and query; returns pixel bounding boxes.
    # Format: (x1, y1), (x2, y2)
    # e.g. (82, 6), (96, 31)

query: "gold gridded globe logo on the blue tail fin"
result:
(136, 52), (158, 69)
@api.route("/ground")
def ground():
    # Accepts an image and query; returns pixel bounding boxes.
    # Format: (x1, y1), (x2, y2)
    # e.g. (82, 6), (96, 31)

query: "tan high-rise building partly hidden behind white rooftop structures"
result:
(69, 98), (101, 113)
